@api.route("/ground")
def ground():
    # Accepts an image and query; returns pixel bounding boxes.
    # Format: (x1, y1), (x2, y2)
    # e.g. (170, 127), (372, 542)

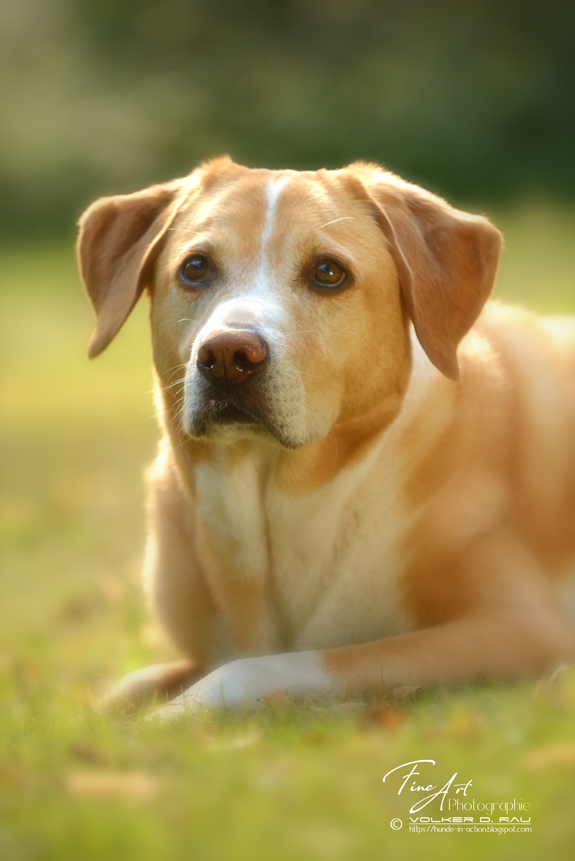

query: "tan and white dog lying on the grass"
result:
(78, 158), (575, 717)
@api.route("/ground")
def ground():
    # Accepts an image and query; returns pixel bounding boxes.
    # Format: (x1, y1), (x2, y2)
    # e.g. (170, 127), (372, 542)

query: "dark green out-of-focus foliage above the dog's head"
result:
(0, 0), (575, 234)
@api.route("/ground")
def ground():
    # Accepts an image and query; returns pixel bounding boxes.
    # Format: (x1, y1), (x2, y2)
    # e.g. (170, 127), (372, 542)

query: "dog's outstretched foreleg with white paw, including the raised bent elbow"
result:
(152, 536), (575, 718)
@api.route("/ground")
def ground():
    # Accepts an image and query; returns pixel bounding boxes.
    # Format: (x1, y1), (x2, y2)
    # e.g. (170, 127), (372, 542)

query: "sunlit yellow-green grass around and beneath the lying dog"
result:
(0, 204), (575, 861)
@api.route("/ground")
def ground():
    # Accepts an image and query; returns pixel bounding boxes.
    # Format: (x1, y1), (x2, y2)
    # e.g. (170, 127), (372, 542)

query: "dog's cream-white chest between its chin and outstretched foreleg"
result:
(197, 444), (410, 651)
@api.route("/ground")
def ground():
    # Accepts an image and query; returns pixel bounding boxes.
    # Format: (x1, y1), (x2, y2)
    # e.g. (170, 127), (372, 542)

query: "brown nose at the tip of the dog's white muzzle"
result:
(198, 329), (267, 384)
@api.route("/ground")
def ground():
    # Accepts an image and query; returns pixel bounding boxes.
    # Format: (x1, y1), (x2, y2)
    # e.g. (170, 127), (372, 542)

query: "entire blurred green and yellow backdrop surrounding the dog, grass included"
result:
(0, 0), (575, 861)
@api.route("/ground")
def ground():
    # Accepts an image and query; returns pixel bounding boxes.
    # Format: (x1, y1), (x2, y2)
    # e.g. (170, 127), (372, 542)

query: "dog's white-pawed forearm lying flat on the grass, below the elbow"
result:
(153, 617), (575, 718)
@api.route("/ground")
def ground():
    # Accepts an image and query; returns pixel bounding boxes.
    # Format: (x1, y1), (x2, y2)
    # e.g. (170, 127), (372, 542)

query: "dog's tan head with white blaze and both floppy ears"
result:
(79, 159), (500, 448)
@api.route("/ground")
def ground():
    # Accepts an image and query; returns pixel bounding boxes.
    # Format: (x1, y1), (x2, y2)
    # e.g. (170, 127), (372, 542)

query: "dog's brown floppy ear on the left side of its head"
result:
(78, 180), (184, 359)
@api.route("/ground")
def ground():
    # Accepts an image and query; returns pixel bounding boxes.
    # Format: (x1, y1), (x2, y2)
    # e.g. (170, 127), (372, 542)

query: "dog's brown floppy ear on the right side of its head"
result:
(348, 172), (502, 380)
